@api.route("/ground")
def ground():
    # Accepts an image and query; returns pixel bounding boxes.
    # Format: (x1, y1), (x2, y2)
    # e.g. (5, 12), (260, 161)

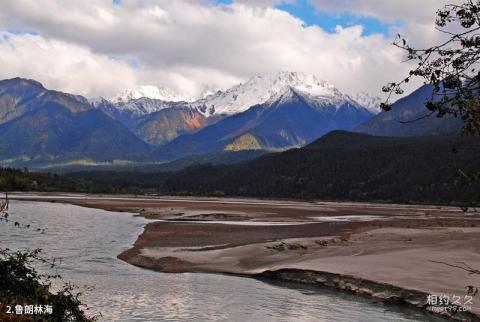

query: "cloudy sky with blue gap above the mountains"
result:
(0, 0), (460, 97)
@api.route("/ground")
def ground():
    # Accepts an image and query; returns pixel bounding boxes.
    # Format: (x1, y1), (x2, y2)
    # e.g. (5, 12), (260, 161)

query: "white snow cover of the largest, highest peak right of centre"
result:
(194, 72), (342, 116)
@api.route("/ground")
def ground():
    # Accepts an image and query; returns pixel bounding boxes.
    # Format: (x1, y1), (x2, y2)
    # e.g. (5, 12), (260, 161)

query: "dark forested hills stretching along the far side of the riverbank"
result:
(0, 131), (480, 205)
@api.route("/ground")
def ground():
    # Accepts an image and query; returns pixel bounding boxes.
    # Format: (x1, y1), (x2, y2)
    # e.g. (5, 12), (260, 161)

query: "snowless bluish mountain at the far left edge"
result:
(0, 78), (150, 163)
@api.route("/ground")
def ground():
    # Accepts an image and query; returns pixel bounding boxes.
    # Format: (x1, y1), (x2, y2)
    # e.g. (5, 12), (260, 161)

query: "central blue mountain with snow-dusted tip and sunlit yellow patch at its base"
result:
(157, 83), (373, 159)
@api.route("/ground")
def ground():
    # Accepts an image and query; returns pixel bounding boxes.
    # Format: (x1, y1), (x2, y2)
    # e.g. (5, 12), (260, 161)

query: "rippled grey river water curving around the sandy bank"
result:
(0, 201), (442, 322)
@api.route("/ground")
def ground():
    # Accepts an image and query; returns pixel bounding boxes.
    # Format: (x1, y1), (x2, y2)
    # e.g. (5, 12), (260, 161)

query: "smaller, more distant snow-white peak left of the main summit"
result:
(110, 85), (193, 103)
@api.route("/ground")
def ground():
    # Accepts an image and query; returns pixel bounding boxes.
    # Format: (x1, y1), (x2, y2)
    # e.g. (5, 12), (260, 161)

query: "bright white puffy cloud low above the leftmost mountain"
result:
(0, 32), (138, 96)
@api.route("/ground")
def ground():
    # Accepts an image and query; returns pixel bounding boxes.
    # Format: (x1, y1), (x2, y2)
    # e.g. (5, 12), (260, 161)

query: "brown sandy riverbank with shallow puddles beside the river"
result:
(10, 192), (480, 321)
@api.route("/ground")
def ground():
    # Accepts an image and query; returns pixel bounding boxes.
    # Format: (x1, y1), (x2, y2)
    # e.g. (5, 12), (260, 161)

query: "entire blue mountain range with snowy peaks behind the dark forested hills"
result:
(0, 72), (461, 166)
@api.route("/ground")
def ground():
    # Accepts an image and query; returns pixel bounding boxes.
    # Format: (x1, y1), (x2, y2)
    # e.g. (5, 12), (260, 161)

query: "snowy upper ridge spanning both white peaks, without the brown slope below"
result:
(99, 72), (381, 117)
